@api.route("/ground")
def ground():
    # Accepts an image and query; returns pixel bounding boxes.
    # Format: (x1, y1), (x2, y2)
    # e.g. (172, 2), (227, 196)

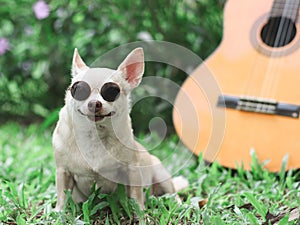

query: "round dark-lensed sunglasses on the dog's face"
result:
(68, 81), (121, 102)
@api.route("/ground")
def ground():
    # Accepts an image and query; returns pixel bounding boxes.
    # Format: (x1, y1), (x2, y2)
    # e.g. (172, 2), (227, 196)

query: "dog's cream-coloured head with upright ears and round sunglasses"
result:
(66, 48), (144, 123)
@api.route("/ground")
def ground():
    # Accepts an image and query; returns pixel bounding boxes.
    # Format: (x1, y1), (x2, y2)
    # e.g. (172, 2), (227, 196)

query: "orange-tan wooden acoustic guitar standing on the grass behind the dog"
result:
(173, 0), (300, 172)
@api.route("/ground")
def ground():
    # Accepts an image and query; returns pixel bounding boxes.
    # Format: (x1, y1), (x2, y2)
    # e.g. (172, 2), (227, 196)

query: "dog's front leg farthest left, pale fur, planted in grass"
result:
(55, 167), (74, 211)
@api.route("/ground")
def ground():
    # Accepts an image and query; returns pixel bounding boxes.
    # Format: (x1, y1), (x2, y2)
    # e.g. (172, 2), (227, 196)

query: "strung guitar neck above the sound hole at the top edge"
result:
(270, 0), (300, 22)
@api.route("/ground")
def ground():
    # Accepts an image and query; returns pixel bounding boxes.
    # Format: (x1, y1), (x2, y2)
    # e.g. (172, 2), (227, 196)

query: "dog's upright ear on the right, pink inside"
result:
(118, 48), (144, 88)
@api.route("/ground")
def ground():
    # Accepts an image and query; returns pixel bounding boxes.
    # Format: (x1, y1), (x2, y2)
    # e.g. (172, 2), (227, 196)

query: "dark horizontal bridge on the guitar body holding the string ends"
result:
(217, 95), (300, 118)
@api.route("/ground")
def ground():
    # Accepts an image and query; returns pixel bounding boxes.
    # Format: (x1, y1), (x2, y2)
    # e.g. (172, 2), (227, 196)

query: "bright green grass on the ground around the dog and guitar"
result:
(0, 124), (300, 225)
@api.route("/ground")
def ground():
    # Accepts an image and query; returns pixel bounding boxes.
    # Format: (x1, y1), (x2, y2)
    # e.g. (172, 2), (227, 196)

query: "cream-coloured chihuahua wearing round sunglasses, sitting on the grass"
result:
(52, 48), (185, 211)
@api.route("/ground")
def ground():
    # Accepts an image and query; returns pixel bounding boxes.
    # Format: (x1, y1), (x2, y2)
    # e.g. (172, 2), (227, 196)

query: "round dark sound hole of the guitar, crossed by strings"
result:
(261, 17), (296, 48)
